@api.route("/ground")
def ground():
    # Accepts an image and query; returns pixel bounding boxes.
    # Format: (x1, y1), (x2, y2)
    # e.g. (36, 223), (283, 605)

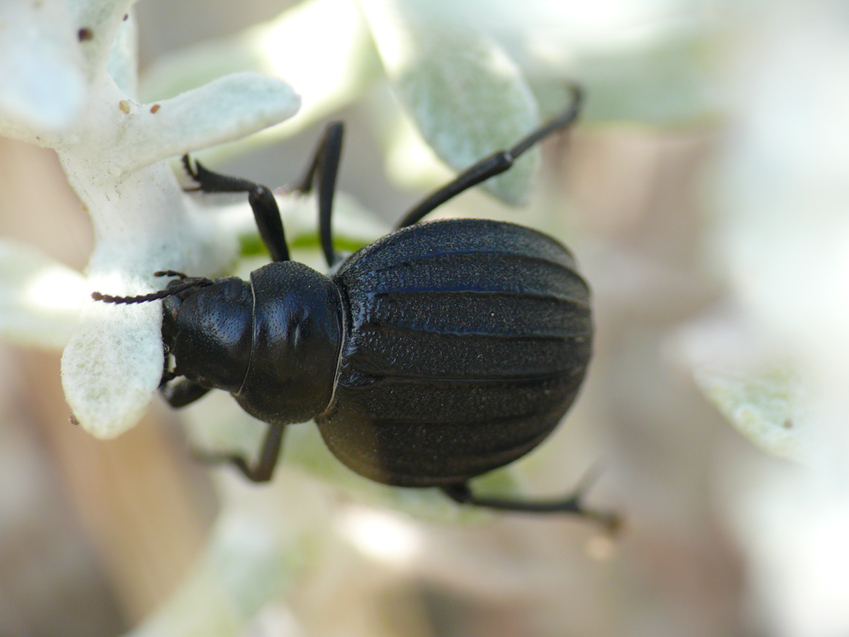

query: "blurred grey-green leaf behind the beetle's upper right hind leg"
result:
(360, 0), (538, 204)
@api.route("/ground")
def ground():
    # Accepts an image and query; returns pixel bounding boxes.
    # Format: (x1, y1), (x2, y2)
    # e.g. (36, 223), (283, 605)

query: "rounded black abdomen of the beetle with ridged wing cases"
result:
(317, 219), (592, 486)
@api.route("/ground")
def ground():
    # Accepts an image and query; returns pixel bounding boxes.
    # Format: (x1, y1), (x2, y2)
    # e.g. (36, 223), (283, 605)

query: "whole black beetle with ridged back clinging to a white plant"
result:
(93, 88), (617, 527)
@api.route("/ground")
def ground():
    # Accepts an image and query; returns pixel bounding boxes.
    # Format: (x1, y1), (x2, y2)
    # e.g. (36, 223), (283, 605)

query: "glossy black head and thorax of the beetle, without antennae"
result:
(162, 261), (342, 424)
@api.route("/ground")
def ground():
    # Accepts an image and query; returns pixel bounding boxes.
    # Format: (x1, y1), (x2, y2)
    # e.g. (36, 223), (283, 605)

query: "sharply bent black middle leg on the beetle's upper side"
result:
(291, 122), (345, 267)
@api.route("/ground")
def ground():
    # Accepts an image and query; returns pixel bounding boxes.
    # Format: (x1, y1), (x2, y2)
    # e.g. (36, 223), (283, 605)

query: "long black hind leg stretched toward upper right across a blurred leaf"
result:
(397, 86), (581, 228)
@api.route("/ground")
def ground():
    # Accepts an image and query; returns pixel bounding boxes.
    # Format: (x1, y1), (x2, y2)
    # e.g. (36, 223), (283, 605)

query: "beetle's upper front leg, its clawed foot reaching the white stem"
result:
(183, 155), (289, 261)
